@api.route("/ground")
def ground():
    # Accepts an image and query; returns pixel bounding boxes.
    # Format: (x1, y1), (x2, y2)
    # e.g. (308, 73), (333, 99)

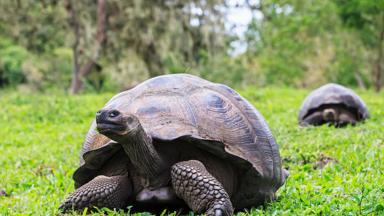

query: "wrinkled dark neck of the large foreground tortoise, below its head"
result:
(123, 125), (165, 179)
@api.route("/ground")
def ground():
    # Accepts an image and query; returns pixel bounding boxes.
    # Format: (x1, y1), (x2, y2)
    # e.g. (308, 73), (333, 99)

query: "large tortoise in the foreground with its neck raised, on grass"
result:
(60, 74), (287, 215)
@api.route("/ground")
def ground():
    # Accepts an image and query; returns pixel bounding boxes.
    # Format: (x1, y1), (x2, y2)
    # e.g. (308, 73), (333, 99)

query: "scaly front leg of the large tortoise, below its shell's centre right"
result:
(171, 160), (233, 216)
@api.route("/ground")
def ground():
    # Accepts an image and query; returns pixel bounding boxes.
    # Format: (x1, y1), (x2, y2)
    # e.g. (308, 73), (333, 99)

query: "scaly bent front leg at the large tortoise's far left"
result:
(59, 175), (132, 212)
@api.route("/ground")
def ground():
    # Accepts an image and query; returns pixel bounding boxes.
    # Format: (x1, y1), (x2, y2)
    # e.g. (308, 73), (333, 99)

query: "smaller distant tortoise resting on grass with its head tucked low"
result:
(299, 83), (369, 127)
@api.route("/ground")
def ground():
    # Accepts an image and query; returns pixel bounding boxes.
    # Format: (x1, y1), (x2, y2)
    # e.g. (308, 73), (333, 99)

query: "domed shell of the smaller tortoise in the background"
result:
(298, 83), (369, 122)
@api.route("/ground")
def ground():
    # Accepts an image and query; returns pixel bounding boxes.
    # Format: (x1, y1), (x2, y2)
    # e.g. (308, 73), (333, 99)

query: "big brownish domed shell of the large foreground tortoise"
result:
(74, 74), (286, 207)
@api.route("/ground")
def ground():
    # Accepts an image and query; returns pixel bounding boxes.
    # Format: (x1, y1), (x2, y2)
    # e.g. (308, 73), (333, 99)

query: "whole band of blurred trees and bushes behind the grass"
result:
(0, 0), (384, 93)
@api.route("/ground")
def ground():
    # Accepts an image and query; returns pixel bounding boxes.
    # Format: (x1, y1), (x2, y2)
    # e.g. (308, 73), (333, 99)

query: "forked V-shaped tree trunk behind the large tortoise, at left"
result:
(66, 0), (106, 94)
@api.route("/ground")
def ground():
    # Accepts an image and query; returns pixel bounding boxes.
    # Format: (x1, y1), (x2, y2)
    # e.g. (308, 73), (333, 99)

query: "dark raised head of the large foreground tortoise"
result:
(96, 109), (140, 141)
